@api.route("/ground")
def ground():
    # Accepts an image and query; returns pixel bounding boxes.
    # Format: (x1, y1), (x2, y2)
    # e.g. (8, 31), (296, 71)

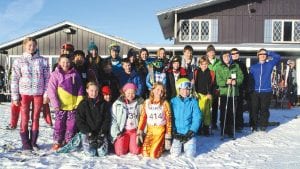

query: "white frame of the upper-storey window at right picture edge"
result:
(271, 19), (300, 43)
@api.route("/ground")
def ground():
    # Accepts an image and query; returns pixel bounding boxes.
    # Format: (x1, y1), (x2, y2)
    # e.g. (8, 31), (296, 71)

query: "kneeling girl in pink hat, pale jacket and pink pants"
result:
(110, 83), (144, 156)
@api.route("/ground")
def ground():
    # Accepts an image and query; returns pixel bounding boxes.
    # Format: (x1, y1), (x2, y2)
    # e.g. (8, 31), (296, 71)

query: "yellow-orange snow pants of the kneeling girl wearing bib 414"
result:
(142, 126), (166, 158)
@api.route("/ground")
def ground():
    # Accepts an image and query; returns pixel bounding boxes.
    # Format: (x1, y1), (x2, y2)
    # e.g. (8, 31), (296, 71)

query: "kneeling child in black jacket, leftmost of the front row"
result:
(58, 82), (110, 157)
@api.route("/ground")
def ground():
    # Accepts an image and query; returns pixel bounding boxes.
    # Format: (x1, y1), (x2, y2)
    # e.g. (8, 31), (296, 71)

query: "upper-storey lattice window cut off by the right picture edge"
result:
(271, 20), (300, 43)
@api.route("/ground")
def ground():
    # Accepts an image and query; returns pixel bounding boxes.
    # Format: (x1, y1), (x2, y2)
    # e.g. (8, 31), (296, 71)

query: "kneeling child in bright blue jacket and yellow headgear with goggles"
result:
(170, 78), (202, 157)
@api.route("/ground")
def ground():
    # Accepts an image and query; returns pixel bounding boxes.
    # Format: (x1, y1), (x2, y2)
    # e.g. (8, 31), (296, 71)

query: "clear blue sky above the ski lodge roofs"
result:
(0, 0), (195, 44)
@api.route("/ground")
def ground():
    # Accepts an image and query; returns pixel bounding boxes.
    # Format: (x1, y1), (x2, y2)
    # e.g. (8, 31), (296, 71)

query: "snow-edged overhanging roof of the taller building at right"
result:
(156, 0), (230, 39)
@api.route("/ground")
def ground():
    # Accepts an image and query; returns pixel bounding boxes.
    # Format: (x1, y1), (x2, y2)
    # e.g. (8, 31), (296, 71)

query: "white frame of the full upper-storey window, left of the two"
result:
(179, 19), (212, 42)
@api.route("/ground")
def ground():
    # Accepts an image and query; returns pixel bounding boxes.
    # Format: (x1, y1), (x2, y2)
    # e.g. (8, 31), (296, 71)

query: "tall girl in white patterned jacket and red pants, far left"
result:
(11, 37), (49, 150)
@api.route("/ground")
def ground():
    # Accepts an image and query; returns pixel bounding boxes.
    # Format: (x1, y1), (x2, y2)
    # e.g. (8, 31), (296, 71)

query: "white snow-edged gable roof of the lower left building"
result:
(0, 21), (139, 49)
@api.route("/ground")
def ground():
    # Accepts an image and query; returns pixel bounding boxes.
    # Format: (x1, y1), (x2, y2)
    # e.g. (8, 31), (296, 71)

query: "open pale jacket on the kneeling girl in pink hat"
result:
(110, 96), (144, 142)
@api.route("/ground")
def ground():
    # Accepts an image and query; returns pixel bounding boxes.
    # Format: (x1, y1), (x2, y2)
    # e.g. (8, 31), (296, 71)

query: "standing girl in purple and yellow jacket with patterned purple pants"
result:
(47, 54), (83, 150)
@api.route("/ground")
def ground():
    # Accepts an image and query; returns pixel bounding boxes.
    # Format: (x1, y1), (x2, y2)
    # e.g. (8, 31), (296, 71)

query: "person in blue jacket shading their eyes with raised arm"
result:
(249, 48), (280, 132)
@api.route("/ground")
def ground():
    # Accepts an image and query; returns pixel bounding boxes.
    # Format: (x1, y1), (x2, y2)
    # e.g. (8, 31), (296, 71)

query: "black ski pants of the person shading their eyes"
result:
(251, 92), (272, 128)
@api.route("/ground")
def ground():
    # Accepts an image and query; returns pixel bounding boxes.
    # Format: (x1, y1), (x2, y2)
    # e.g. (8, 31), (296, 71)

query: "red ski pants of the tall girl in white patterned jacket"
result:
(20, 95), (43, 133)
